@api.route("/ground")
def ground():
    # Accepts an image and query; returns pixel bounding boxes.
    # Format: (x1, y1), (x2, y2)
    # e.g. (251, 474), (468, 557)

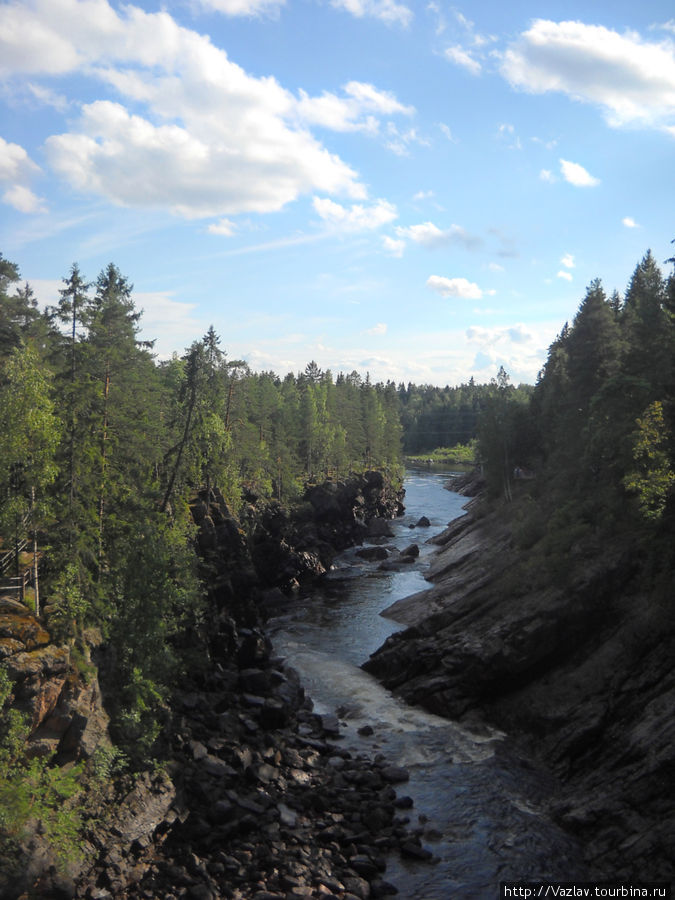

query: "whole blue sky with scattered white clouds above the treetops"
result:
(0, 0), (675, 386)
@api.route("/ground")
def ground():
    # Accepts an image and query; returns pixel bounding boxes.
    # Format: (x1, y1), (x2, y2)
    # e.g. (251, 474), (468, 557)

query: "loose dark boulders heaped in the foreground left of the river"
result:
(76, 629), (431, 900)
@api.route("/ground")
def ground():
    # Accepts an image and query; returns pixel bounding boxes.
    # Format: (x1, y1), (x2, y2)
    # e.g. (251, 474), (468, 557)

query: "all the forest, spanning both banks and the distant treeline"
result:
(0, 244), (675, 880)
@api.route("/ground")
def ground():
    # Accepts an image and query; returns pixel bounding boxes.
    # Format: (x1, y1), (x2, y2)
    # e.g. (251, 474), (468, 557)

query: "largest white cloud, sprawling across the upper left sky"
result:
(0, 0), (418, 218)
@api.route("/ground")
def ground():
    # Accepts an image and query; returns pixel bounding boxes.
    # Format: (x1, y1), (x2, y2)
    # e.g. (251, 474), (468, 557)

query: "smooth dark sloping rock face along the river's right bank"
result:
(364, 500), (675, 880)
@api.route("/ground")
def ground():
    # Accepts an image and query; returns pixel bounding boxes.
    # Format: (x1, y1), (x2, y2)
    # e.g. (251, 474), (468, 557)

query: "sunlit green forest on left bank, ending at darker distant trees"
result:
(0, 251), (401, 758)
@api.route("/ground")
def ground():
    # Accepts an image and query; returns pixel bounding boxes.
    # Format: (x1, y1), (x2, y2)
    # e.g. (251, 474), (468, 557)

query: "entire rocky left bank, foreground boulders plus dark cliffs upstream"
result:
(0, 472), (438, 900)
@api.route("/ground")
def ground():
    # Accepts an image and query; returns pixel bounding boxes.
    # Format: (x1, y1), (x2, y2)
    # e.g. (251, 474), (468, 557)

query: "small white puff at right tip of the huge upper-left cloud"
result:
(297, 81), (415, 132)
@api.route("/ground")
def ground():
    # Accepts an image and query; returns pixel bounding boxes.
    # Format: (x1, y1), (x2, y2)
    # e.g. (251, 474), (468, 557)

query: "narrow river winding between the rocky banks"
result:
(271, 469), (584, 900)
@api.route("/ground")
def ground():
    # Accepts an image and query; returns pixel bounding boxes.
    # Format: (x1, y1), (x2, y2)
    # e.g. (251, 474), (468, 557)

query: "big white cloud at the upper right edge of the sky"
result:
(502, 19), (675, 133)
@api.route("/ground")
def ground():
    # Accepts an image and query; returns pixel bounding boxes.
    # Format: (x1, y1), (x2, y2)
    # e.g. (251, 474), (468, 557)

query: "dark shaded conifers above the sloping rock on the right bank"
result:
(479, 252), (675, 595)
